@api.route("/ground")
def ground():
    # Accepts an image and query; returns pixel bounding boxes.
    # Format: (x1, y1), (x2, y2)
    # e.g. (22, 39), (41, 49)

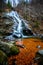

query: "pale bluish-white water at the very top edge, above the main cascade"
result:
(4, 0), (32, 7)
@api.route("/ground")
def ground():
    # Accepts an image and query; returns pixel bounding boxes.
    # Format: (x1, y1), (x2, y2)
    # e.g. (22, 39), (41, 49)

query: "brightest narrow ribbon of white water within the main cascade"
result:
(7, 11), (22, 33)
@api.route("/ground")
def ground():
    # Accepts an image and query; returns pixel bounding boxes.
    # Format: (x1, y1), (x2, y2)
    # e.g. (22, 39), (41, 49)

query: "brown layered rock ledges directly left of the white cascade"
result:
(0, 14), (14, 37)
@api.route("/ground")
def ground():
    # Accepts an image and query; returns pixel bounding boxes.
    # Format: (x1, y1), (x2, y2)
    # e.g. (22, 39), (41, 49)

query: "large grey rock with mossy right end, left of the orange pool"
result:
(0, 42), (19, 56)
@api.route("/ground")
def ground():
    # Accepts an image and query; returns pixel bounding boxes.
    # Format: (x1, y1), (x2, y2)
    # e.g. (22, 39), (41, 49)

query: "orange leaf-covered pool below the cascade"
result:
(8, 38), (43, 65)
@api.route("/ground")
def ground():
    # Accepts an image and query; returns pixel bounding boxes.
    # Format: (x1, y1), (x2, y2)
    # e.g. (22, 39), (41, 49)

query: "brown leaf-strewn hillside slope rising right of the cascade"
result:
(15, 3), (43, 34)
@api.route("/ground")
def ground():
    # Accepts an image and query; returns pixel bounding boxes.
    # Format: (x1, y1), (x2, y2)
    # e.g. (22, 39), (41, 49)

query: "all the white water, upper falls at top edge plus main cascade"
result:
(4, 0), (34, 37)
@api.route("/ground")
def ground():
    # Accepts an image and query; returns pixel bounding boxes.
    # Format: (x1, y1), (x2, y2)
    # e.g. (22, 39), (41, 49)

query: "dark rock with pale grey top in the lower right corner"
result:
(35, 50), (43, 65)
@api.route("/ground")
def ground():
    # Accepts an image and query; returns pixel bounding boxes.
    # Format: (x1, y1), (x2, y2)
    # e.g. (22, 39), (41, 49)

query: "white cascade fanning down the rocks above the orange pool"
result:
(6, 11), (31, 37)
